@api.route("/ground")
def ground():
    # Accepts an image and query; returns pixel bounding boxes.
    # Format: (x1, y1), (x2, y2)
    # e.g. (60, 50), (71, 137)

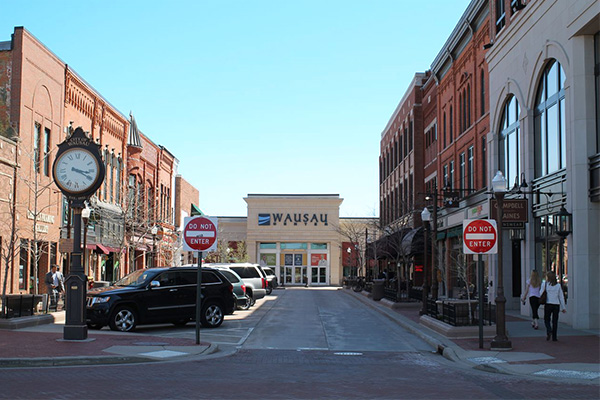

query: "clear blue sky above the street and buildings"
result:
(0, 0), (469, 216)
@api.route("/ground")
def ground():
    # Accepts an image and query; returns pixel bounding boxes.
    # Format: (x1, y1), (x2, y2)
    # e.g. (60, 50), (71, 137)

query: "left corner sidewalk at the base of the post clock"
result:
(0, 312), (218, 368)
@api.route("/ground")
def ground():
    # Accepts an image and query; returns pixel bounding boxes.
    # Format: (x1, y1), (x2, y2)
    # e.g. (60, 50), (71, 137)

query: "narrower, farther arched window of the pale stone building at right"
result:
(499, 96), (522, 186)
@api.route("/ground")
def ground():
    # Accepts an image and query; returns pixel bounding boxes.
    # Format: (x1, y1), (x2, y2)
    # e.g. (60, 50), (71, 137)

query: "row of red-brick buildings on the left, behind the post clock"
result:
(0, 27), (184, 293)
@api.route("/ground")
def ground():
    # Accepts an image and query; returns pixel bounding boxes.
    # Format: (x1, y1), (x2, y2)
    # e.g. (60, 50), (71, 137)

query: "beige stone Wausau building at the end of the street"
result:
(213, 194), (370, 286)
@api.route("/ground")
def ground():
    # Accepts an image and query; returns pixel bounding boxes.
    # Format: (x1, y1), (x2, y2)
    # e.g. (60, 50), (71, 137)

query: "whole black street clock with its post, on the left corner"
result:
(52, 127), (106, 340)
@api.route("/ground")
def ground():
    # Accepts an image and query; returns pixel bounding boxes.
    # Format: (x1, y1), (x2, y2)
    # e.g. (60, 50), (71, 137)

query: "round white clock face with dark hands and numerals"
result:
(54, 148), (99, 193)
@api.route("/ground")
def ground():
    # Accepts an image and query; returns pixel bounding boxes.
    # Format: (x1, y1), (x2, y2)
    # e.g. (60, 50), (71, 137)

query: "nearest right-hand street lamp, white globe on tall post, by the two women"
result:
(491, 171), (512, 350)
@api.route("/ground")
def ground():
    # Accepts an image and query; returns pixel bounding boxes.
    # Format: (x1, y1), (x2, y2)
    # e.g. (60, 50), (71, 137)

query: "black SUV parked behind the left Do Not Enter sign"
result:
(86, 267), (235, 332)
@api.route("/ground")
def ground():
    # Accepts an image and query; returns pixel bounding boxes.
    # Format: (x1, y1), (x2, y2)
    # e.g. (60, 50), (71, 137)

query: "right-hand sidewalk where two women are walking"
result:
(344, 289), (600, 384)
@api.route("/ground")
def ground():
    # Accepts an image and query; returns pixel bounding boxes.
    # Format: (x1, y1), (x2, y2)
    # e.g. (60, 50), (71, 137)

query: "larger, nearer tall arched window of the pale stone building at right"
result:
(534, 60), (567, 177)
